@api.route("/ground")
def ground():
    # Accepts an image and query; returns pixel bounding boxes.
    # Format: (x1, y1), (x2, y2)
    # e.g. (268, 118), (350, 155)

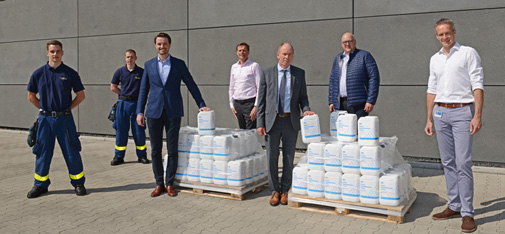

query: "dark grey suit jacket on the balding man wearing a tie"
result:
(257, 65), (310, 133)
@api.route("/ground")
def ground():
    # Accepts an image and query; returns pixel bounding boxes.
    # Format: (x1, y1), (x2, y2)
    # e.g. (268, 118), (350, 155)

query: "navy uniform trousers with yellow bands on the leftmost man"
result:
(33, 114), (85, 188)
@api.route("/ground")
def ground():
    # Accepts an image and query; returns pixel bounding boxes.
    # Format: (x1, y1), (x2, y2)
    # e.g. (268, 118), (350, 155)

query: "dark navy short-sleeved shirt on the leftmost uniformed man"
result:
(27, 63), (84, 112)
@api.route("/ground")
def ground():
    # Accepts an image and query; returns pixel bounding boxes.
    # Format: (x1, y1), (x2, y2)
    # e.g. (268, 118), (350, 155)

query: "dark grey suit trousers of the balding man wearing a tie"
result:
(265, 117), (298, 193)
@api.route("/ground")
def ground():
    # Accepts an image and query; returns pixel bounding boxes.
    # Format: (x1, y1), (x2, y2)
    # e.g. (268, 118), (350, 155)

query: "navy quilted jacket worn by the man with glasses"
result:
(328, 49), (380, 110)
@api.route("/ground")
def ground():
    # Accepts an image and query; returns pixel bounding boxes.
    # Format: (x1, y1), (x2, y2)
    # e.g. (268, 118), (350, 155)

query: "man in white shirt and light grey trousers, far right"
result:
(424, 18), (484, 232)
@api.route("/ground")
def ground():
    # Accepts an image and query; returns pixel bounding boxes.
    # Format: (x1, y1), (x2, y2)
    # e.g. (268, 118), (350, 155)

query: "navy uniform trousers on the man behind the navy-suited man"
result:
(112, 100), (147, 158)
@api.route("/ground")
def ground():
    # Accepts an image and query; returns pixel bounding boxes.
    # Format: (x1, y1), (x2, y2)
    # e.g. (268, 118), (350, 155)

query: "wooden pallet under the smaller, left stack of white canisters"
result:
(174, 178), (268, 201)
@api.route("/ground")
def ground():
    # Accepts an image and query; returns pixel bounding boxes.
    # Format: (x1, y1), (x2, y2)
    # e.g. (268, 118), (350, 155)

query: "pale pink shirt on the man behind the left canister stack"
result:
(228, 59), (261, 108)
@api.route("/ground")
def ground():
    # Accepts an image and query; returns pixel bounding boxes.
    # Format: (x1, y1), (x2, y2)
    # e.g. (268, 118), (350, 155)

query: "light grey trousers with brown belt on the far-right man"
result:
(433, 104), (475, 217)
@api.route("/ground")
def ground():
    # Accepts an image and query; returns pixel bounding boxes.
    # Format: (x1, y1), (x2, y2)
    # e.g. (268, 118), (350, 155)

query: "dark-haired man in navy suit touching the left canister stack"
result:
(137, 33), (210, 197)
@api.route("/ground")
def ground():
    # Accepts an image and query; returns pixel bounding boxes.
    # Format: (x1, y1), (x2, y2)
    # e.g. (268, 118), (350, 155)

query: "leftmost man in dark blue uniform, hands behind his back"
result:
(27, 40), (87, 198)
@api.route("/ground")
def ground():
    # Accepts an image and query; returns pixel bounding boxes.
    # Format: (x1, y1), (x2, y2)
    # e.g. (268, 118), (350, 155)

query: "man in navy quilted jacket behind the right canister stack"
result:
(328, 32), (380, 118)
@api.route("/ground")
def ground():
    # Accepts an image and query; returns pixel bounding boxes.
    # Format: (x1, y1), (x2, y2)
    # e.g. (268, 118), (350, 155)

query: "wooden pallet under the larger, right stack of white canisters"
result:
(288, 189), (417, 223)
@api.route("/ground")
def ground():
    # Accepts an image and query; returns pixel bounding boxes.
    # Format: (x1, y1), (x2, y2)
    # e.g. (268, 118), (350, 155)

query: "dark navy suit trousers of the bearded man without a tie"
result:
(147, 109), (181, 186)
